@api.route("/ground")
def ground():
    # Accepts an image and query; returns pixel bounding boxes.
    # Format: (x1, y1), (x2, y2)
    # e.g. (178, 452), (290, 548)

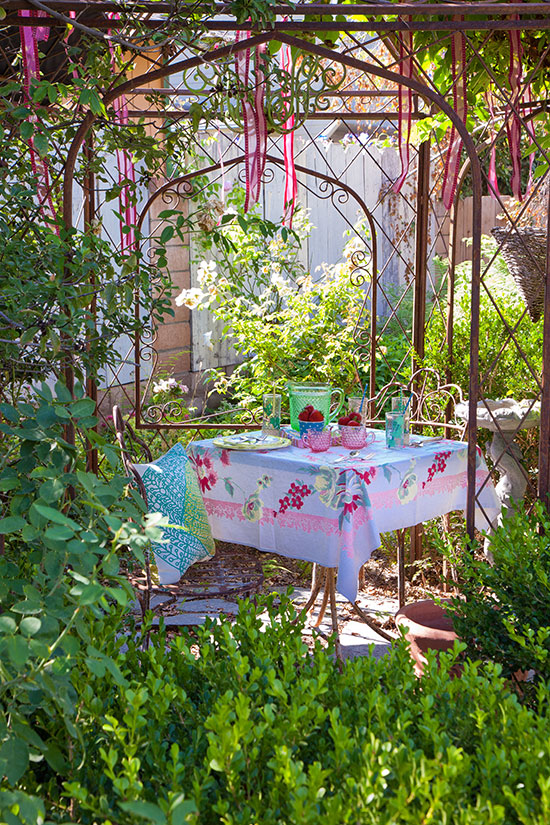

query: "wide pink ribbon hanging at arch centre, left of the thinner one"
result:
(235, 31), (267, 213)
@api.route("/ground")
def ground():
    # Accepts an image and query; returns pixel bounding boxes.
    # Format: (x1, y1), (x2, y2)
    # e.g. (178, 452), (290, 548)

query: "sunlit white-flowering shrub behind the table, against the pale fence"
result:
(176, 206), (365, 403)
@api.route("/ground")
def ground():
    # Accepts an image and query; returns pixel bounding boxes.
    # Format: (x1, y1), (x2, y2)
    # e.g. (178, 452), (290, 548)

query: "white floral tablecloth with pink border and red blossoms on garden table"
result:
(187, 431), (500, 601)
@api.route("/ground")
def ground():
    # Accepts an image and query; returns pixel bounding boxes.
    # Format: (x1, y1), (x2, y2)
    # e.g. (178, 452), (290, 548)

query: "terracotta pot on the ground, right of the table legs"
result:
(395, 599), (460, 676)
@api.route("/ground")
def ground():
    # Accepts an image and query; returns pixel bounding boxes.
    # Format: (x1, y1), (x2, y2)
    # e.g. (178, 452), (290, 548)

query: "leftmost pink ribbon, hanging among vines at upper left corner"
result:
(18, 9), (59, 235)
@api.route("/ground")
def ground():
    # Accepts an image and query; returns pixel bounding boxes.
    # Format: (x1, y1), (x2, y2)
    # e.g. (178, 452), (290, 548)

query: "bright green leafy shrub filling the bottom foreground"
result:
(19, 599), (550, 825)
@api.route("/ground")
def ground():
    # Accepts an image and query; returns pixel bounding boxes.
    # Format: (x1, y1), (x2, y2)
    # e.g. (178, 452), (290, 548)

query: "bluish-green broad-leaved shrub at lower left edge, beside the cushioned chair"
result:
(0, 384), (165, 825)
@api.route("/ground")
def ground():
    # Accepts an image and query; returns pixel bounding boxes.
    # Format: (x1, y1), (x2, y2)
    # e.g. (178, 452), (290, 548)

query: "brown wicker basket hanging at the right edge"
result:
(491, 226), (546, 322)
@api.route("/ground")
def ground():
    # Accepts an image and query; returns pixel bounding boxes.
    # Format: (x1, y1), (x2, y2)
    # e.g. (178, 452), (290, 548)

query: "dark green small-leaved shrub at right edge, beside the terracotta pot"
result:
(446, 504), (550, 682)
